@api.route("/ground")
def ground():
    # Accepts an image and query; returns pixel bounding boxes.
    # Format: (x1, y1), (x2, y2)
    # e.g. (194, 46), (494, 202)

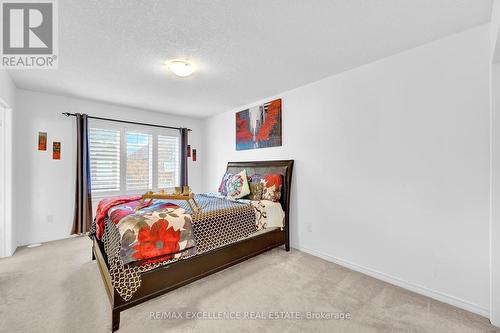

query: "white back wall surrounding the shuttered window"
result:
(14, 90), (202, 245)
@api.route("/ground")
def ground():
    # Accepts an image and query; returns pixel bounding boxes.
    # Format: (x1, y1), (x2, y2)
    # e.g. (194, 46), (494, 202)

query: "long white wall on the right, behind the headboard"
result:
(203, 25), (490, 315)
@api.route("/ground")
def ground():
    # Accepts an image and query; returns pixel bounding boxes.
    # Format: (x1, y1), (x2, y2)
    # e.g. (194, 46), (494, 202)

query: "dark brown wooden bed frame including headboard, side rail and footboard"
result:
(92, 160), (293, 332)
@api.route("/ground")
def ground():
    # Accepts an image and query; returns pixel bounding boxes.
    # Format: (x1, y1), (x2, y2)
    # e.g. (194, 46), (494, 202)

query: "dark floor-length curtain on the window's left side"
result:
(71, 113), (92, 234)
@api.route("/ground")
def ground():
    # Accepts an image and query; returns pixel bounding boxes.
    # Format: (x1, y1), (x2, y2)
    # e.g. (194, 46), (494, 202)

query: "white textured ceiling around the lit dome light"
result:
(6, 0), (491, 117)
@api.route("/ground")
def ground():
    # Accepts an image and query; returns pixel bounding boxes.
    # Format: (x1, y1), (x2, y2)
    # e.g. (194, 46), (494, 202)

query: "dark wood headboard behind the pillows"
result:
(226, 160), (293, 247)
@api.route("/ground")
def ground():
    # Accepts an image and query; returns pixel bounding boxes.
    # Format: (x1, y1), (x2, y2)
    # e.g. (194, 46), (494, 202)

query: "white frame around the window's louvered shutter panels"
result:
(88, 119), (182, 200)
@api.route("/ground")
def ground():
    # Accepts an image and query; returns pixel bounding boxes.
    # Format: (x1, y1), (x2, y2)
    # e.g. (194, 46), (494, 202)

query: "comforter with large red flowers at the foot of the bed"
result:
(97, 198), (195, 264)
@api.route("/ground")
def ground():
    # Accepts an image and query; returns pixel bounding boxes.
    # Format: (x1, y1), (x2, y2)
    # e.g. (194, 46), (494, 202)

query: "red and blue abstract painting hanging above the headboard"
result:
(236, 99), (281, 150)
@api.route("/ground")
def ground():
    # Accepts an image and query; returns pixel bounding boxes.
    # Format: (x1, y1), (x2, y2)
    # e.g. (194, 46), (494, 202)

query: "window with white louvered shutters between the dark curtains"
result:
(89, 120), (180, 198)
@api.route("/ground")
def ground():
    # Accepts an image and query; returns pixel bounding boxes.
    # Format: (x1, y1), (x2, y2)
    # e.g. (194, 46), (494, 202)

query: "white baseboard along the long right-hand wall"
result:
(292, 244), (490, 318)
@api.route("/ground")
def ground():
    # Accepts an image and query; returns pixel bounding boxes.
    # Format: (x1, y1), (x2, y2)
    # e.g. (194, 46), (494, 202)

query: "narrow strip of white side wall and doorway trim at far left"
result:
(0, 69), (17, 256)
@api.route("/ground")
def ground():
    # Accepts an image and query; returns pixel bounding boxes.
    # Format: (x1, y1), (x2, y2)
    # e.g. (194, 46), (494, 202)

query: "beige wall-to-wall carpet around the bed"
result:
(0, 237), (500, 333)
